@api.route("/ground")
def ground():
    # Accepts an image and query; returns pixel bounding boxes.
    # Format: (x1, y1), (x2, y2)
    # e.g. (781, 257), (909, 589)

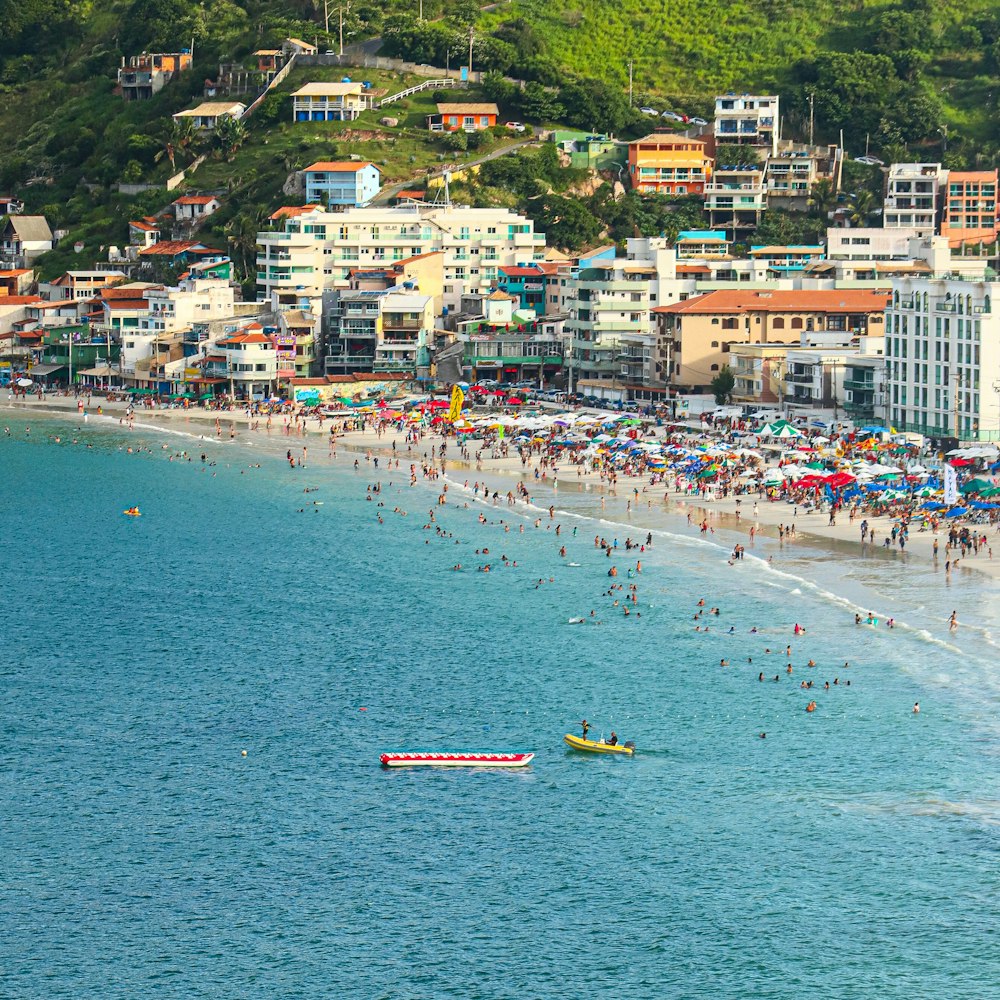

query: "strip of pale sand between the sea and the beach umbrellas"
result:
(2, 395), (1000, 580)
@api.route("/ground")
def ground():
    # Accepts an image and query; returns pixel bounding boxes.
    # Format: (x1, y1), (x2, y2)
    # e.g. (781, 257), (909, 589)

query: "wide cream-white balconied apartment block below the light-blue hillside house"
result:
(257, 204), (545, 311)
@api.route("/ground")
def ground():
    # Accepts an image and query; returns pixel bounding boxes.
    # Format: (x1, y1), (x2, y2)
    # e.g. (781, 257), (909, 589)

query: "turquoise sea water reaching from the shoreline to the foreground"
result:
(0, 421), (1000, 998)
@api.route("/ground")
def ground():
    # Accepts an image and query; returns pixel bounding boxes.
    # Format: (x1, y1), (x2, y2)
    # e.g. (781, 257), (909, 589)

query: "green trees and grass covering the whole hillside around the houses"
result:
(0, 0), (1000, 281)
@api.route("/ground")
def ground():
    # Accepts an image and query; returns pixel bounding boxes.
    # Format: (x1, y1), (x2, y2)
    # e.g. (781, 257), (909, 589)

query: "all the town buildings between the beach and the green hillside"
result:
(0, 68), (1000, 438)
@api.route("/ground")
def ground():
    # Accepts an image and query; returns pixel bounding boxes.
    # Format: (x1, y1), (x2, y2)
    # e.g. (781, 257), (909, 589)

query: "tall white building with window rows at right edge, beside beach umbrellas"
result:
(885, 277), (1000, 441)
